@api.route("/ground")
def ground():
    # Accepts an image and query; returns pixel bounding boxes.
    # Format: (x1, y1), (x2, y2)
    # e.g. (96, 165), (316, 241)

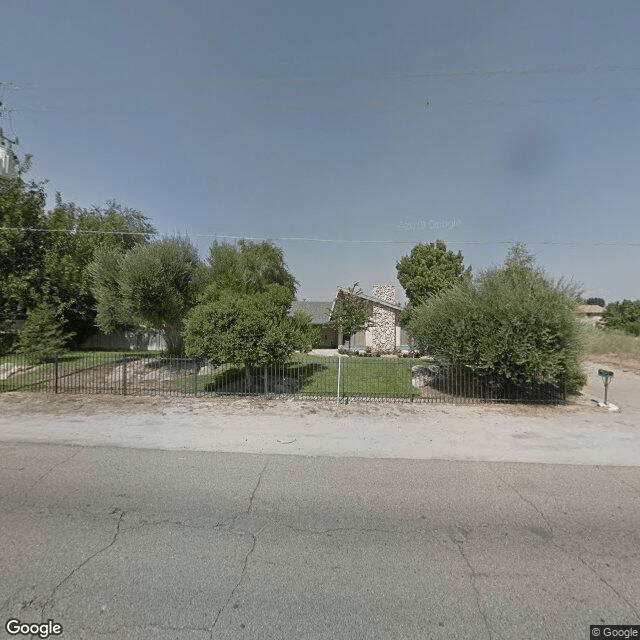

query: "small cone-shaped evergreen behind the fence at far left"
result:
(16, 303), (70, 363)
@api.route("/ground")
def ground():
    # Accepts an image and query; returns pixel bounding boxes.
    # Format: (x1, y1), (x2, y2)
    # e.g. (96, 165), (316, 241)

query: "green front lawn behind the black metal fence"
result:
(0, 350), (564, 398)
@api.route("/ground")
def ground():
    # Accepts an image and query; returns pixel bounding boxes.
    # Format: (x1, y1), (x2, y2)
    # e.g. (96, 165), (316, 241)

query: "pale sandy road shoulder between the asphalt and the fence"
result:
(0, 356), (640, 466)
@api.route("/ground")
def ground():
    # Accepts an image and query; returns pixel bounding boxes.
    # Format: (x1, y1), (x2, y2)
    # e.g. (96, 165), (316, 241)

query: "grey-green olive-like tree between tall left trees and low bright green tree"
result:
(90, 238), (204, 353)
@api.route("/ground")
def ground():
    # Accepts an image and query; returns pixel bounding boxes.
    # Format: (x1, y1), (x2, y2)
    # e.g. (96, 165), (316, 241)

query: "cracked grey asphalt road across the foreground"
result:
(0, 443), (640, 640)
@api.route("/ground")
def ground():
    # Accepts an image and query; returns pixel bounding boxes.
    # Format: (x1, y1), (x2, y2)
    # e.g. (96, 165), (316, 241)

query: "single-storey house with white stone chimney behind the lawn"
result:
(290, 284), (412, 351)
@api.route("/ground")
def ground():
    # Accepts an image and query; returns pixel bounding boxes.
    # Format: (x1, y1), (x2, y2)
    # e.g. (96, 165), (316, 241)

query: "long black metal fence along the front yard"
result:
(0, 351), (566, 403)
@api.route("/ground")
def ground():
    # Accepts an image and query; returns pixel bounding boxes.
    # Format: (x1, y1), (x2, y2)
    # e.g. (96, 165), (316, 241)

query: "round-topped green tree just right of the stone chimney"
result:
(396, 240), (471, 307)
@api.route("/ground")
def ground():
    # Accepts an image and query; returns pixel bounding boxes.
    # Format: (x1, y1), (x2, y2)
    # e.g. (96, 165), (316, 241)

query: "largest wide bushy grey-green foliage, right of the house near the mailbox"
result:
(410, 245), (585, 389)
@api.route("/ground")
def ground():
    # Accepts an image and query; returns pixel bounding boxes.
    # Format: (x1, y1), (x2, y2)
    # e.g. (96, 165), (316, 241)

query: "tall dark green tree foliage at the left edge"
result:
(0, 169), (154, 343)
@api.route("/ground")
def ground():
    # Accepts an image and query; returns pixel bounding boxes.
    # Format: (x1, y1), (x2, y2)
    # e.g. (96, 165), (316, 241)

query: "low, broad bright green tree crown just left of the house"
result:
(185, 284), (314, 367)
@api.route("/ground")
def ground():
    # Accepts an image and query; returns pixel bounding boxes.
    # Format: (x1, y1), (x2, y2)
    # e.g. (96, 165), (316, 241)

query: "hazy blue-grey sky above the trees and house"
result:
(0, 0), (640, 302)
